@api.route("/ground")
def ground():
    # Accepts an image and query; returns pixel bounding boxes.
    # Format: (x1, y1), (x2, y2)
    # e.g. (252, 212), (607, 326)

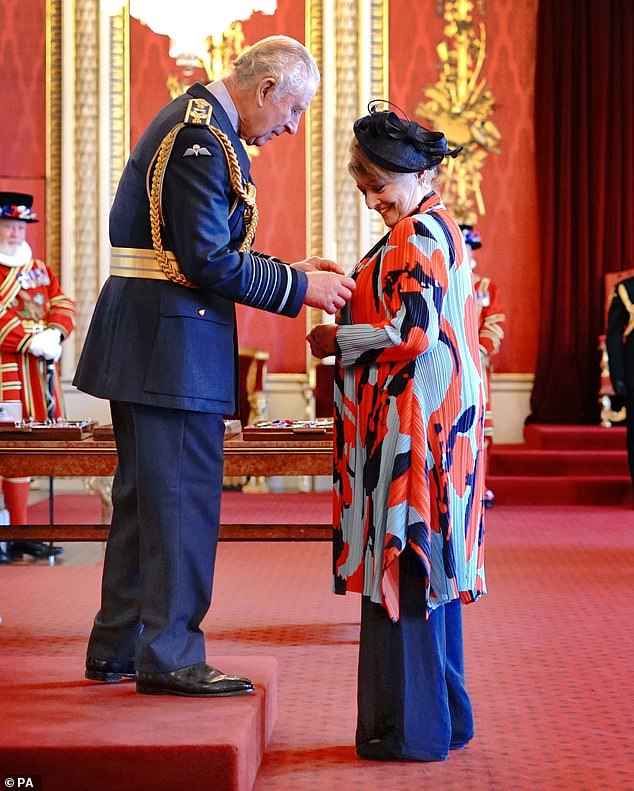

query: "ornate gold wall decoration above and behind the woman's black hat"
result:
(415, 0), (501, 225)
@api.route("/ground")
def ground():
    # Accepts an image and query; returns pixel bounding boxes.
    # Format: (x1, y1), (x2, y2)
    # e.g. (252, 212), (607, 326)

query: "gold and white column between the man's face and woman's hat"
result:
(306, 0), (389, 397)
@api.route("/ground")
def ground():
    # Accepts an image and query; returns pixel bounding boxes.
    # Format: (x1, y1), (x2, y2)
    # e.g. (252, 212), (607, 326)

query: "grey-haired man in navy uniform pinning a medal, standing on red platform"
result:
(75, 36), (354, 697)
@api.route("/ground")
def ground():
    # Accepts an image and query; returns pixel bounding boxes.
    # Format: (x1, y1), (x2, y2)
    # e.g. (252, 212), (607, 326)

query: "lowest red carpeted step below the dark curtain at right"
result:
(487, 475), (632, 505)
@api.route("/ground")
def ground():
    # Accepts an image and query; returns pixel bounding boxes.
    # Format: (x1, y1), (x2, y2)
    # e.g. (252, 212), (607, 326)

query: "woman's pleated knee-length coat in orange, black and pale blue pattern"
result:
(334, 193), (486, 621)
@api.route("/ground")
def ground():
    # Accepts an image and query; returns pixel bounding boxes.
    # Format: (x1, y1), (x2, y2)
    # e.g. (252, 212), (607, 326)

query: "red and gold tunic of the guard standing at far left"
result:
(0, 258), (75, 420)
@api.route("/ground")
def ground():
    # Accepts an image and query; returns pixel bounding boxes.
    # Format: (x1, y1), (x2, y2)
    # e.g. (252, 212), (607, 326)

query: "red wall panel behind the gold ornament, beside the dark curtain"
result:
(390, 0), (540, 372)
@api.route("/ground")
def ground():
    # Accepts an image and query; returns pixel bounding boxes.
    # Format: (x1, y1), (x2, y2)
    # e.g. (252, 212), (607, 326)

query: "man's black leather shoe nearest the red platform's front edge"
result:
(136, 662), (254, 698)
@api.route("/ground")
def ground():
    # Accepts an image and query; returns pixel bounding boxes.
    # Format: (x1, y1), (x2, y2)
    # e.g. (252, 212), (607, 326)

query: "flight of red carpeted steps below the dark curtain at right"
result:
(488, 425), (632, 505)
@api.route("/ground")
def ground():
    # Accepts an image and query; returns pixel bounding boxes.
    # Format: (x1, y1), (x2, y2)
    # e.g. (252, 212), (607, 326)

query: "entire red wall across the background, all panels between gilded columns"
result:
(0, 0), (539, 372)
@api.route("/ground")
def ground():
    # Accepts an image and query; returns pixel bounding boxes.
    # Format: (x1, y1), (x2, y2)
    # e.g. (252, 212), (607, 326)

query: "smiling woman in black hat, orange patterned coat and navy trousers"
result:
(308, 105), (486, 761)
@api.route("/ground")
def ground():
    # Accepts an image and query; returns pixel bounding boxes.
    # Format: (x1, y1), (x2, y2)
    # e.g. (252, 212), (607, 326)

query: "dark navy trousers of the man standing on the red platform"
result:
(87, 401), (224, 673)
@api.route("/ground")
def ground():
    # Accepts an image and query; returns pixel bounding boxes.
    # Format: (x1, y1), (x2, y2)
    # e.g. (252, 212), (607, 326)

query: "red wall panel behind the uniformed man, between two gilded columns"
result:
(130, 0), (306, 372)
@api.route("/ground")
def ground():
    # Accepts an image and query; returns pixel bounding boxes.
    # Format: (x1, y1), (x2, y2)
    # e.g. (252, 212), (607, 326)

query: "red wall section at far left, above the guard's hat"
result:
(0, 0), (46, 257)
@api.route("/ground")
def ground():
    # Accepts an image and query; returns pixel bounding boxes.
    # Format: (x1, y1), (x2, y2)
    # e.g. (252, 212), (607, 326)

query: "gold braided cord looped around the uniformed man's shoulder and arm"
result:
(150, 123), (258, 288)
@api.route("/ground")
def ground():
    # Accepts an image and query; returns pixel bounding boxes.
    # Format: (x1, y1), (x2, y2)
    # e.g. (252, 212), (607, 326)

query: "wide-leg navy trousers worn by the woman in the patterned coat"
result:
(356, 547), (474, 761)
